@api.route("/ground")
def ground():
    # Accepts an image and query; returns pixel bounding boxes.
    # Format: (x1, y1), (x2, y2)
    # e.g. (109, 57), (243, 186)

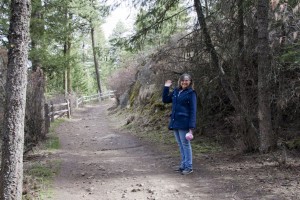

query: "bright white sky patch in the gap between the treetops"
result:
(101, 5), (135, 38)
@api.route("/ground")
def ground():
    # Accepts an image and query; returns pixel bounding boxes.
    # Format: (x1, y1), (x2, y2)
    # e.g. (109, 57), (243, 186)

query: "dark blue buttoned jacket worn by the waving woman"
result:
(162, 86), (197, 130)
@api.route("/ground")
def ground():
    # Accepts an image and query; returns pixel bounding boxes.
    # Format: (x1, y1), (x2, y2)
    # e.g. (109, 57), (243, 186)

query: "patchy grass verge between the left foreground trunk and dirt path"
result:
(22, 119), (64, 200)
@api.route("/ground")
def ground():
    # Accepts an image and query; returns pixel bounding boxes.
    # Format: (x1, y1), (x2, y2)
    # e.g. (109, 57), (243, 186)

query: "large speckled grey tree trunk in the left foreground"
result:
(0, 0), (31, 200)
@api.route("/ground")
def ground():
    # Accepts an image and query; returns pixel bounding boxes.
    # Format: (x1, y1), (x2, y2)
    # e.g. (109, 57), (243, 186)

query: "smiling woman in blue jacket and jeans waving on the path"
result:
(162, 74), (197, 175)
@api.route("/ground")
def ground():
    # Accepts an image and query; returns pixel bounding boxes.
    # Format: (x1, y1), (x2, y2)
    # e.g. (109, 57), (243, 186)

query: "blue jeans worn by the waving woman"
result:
(174, 129), (193, 169)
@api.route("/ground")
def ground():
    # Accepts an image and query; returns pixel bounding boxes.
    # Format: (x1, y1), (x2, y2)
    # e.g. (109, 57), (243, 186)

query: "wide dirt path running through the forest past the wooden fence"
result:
(48, 102), (298, 200)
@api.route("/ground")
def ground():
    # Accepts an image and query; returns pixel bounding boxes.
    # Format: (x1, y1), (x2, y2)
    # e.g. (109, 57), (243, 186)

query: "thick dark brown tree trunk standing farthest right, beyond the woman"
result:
(257, 0), (276, 153)
